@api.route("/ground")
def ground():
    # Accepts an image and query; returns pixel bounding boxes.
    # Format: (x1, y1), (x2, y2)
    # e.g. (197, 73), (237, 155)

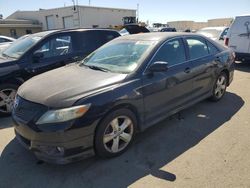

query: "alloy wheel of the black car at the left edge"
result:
(0, 89), (17, 113)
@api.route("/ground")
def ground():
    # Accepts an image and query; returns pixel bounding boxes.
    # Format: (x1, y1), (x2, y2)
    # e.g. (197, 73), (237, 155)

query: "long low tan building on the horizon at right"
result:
(168, 18), (233, 31)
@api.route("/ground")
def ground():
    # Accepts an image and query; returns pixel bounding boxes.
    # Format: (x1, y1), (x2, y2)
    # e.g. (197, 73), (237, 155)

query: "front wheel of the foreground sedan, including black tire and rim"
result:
(95, 109), (137, 158)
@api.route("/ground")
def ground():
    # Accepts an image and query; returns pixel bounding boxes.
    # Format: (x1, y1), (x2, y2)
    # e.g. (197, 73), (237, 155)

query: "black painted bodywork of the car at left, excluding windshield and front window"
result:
(0, 29), (120, 85)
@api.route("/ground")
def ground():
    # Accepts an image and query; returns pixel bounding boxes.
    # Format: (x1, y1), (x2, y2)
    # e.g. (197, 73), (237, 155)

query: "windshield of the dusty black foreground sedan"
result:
(83, 41), (155, 74)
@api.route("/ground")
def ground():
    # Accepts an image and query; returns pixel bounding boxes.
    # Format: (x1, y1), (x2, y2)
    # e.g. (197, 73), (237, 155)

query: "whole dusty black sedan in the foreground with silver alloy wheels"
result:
(13, 33), (234, 164)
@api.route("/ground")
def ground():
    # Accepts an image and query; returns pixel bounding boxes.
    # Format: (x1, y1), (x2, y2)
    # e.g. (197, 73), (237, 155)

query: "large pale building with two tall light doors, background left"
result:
(7, 6), (136, 30)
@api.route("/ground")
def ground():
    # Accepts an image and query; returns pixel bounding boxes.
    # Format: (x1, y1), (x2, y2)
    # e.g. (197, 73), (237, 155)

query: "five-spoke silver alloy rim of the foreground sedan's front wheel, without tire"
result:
(103, 116), (134, 153)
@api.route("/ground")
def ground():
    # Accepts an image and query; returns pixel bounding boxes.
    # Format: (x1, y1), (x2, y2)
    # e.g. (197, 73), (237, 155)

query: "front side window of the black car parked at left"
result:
(36, 36), (72, 58)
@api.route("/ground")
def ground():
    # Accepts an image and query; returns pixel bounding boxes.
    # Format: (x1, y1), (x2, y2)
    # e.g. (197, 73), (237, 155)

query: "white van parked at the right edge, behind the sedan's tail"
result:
(225, 15), (250, 61)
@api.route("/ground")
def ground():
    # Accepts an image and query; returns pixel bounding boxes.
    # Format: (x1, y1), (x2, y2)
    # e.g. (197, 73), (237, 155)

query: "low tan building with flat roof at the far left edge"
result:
(0, 19), (42, 38)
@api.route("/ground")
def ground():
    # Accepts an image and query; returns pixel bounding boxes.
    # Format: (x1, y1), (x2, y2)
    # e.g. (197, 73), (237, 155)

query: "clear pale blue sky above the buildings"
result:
(0, 0), (250, 23)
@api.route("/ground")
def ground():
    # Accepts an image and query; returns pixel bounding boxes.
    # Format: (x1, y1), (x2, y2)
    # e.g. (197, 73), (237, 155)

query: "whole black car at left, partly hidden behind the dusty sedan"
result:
(0, 29), (120, 117)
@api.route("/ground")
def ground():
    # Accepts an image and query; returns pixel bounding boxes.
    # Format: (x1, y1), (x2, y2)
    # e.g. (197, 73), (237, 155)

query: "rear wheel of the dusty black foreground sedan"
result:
(210, 72), (228, 102)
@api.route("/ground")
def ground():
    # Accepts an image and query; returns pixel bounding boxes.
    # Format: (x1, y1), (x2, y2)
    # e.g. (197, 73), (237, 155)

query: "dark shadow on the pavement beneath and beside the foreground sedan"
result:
(0, 93), (244, 188)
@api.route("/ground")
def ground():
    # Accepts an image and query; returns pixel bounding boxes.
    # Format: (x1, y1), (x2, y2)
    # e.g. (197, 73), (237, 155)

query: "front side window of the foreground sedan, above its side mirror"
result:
(153, 39), (186, 66)
